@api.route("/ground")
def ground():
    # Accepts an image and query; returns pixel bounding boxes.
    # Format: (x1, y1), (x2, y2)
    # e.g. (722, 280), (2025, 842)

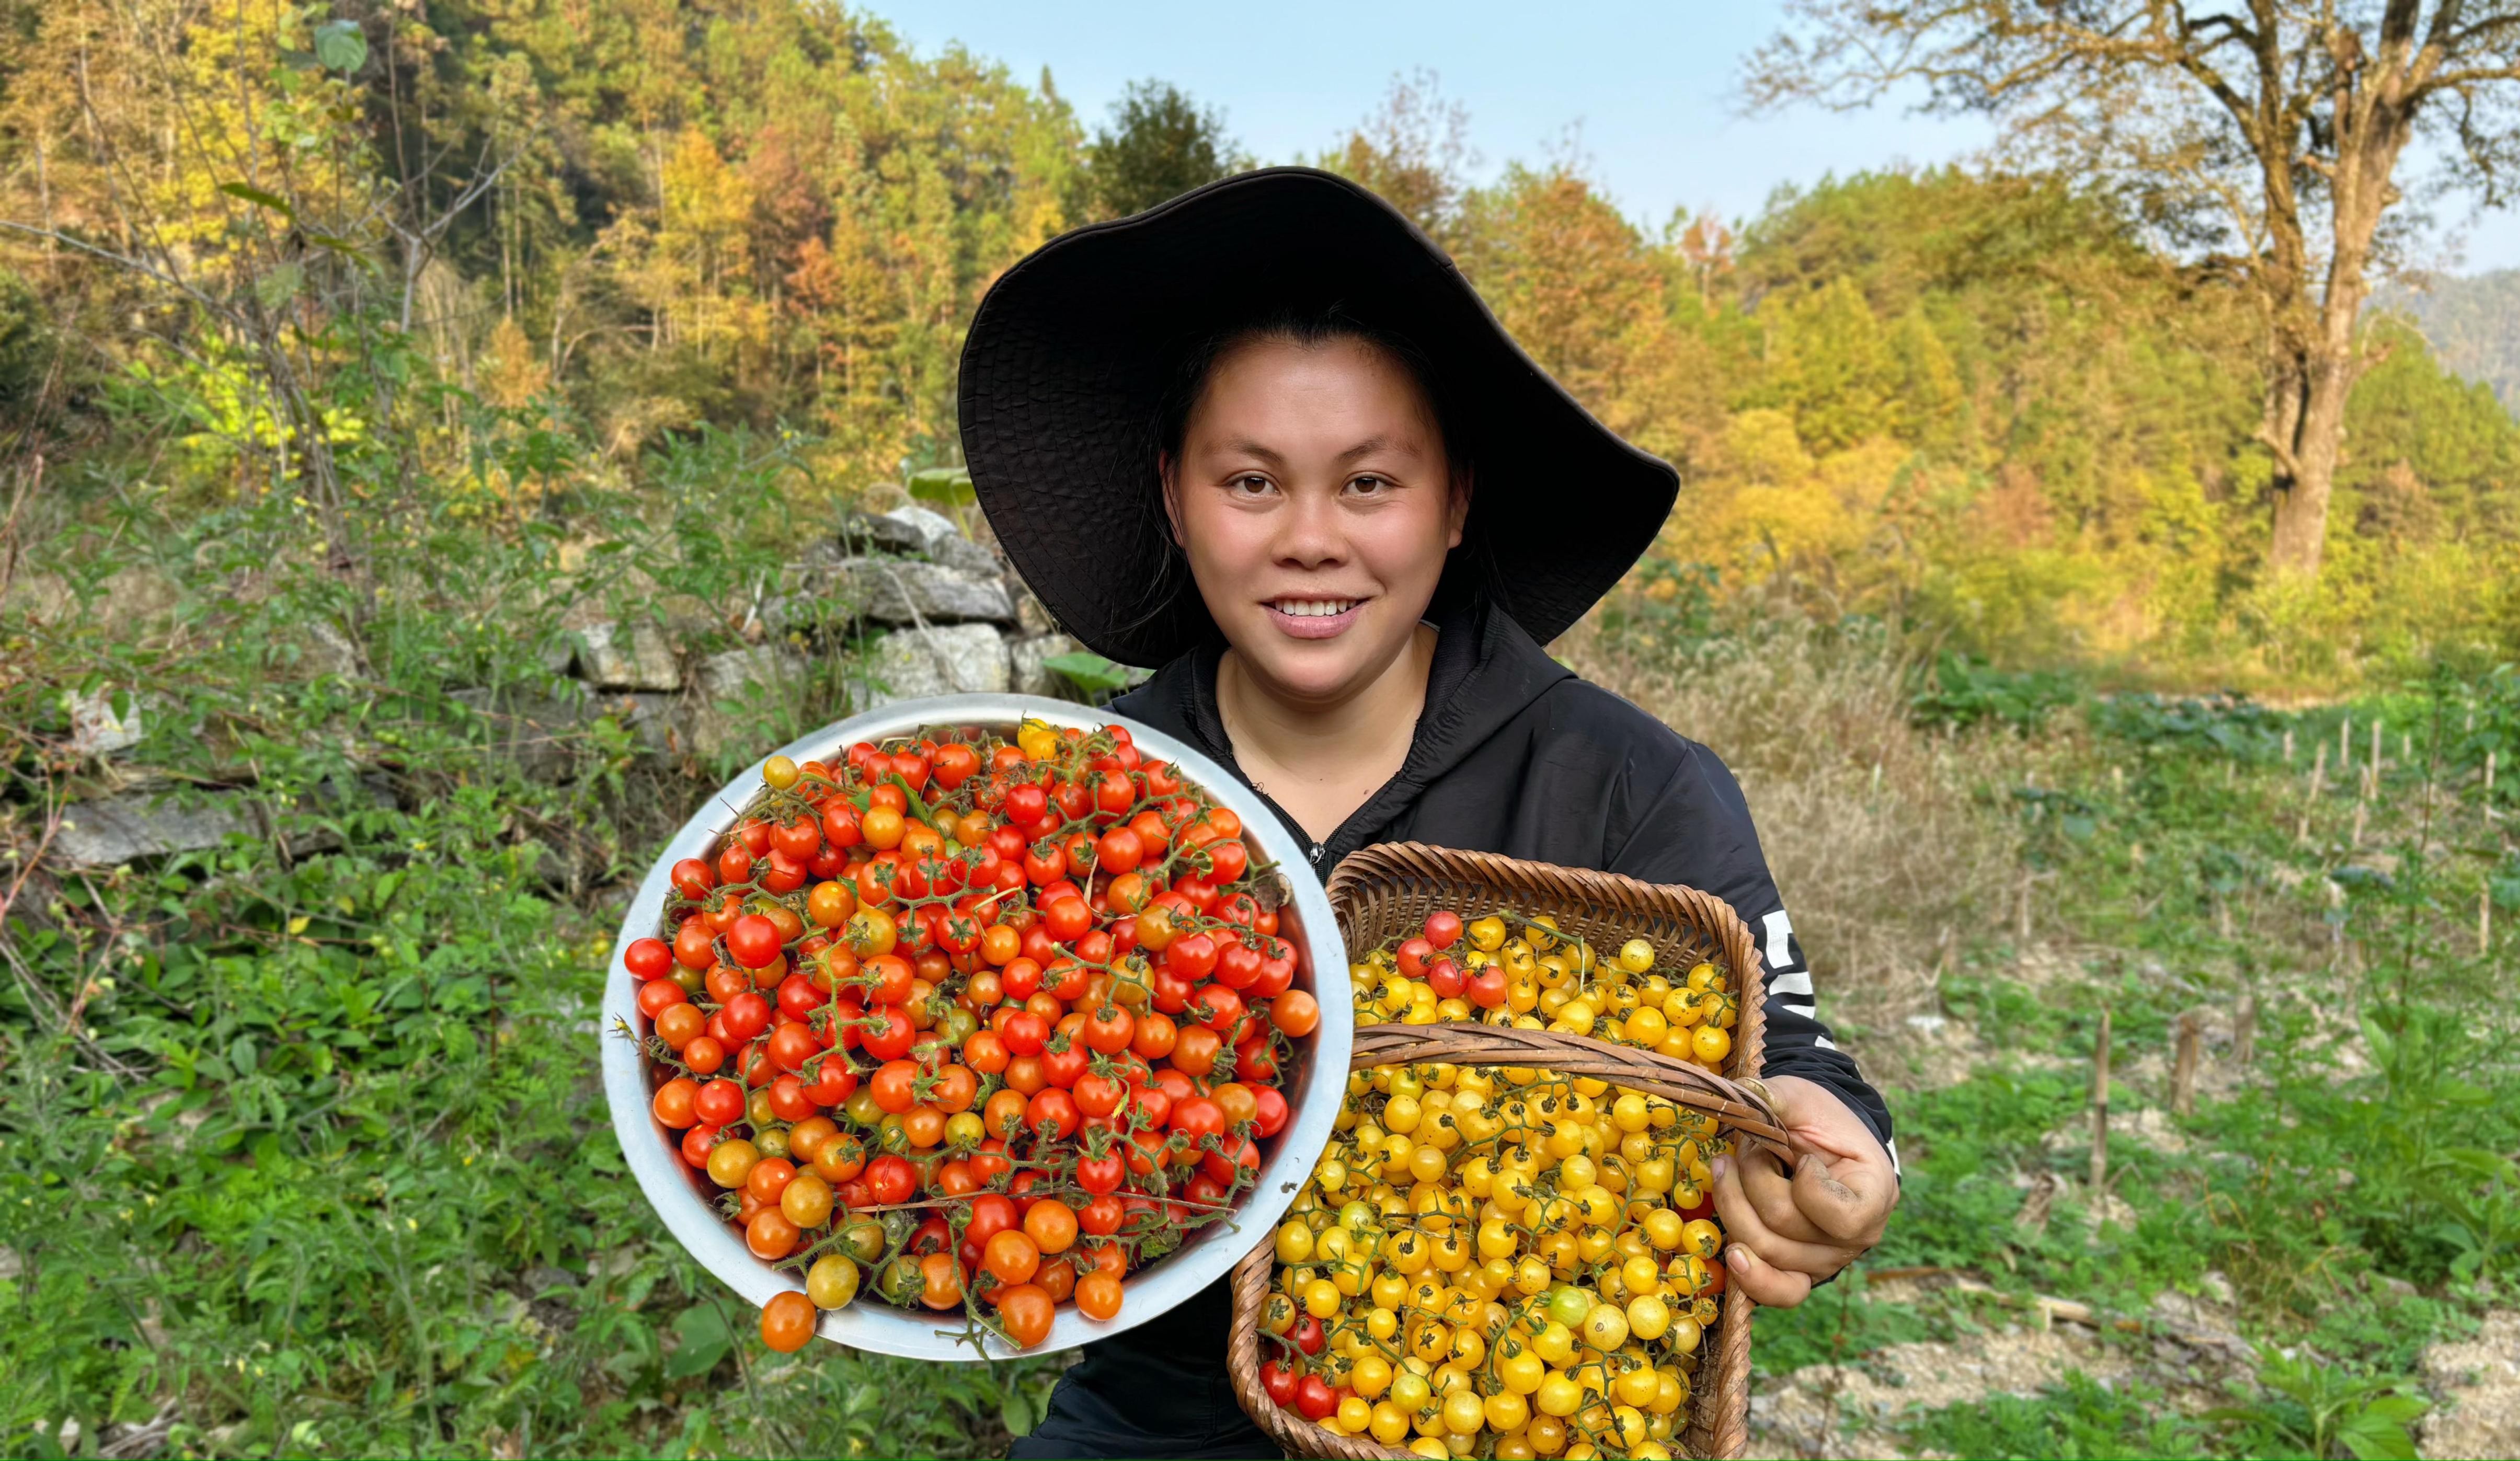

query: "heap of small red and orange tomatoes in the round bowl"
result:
(625, 720), (1321, 1350)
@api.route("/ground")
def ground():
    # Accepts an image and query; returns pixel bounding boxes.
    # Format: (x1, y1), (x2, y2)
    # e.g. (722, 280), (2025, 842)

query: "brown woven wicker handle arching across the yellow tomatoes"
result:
(1348, 1020), (1797, 1169)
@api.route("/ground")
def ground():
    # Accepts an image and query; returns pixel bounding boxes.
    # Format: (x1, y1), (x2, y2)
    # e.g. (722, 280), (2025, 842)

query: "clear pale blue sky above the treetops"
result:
(869, 0), (2520, 270)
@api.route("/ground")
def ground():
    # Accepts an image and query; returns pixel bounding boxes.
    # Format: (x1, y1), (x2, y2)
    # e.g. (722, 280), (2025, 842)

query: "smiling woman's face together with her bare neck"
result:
(1162, 321), (1469, 842)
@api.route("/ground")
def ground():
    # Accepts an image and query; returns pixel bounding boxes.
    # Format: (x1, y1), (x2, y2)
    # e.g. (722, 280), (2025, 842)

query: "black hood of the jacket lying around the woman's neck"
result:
(1112, 602), (1575, 869)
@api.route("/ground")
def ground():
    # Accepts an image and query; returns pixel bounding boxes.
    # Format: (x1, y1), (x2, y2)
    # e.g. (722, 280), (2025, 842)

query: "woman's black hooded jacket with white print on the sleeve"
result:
(1013, 597), (1895, 1456)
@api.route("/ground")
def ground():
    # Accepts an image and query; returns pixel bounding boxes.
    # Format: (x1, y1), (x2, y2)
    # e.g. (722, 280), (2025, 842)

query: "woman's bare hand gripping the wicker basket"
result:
(1714, 1076), (1897, 1310)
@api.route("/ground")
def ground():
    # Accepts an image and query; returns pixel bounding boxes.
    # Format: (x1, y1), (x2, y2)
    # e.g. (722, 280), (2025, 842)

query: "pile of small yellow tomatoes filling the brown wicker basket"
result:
(1260, 910), (1739, 1461)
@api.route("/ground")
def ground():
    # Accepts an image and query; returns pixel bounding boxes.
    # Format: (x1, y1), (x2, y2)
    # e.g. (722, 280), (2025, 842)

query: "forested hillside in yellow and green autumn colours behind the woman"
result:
(0, 0), (2520, 688)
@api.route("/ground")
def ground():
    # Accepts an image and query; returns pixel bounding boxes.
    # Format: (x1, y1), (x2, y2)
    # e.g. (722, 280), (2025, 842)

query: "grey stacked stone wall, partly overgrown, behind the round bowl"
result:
(45, 507), (1124, 867)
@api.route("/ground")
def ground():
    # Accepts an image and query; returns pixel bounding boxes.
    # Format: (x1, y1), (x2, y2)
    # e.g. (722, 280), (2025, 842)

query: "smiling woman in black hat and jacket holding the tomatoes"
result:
(963, 169), (1897, 1456)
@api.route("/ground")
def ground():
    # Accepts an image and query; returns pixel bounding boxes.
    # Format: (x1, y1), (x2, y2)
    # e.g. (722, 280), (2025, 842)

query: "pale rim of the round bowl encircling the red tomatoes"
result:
(597, 695), (1353, 1360)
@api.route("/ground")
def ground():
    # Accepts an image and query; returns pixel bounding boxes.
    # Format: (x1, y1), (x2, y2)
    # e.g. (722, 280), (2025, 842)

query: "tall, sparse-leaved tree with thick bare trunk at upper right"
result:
(1746, 0), (2520, 579)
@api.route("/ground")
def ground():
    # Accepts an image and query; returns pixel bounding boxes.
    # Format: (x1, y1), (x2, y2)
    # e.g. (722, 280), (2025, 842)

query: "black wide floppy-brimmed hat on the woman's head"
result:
(960, 166), (1678, 665)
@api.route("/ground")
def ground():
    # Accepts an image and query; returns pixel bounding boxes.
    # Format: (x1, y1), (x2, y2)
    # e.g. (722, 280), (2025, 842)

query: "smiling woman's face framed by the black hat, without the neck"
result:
(1164, 338), (1469, 703)
